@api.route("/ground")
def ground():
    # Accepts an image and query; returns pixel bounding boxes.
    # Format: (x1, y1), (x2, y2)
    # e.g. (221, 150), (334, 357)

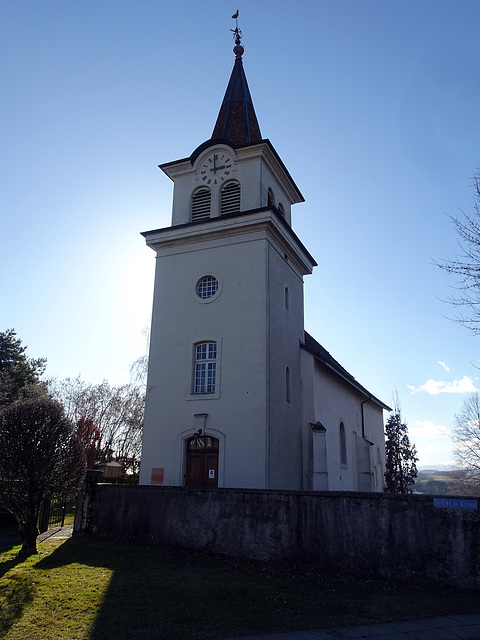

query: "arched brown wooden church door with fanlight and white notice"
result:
(185, 435), (219, 487)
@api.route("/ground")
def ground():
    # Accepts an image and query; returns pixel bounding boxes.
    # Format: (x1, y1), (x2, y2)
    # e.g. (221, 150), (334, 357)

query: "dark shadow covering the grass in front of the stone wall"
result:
(30, 536), (479, 640)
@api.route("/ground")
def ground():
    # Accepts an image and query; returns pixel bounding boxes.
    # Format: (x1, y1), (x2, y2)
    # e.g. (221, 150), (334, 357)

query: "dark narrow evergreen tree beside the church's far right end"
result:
(385, 406), (418, 493)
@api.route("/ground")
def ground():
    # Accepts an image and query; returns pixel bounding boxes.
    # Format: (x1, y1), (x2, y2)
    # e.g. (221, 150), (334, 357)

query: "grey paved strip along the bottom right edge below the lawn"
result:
(218, 614), (480, 640)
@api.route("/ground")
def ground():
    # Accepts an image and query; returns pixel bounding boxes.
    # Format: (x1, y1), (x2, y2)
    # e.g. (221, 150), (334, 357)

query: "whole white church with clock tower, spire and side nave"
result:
(140, 31), (388, 491)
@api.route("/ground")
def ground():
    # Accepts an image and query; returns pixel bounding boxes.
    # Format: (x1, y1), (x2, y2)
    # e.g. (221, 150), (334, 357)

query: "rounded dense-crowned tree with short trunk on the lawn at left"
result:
(0, 396), (85, 557)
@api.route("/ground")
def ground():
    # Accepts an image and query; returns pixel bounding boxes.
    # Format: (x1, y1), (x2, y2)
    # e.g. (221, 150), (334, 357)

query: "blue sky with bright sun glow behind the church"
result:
(0, 0), (480, 465)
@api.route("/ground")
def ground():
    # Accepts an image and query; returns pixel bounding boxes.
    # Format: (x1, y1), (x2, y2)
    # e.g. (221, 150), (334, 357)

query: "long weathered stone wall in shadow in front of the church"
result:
(75, 485), (480, 588)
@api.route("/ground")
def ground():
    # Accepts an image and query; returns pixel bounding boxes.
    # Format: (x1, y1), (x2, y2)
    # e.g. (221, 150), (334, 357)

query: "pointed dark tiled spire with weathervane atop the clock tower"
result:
(212, 20), (262, 146)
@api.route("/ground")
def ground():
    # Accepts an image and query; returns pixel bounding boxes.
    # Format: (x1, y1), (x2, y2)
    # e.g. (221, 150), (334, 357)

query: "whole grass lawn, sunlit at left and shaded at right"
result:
(0, 538), (480, 640)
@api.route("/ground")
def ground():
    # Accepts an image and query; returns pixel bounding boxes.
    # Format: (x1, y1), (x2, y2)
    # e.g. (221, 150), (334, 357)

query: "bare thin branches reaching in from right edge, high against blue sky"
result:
(436, 171), (480, 334)
